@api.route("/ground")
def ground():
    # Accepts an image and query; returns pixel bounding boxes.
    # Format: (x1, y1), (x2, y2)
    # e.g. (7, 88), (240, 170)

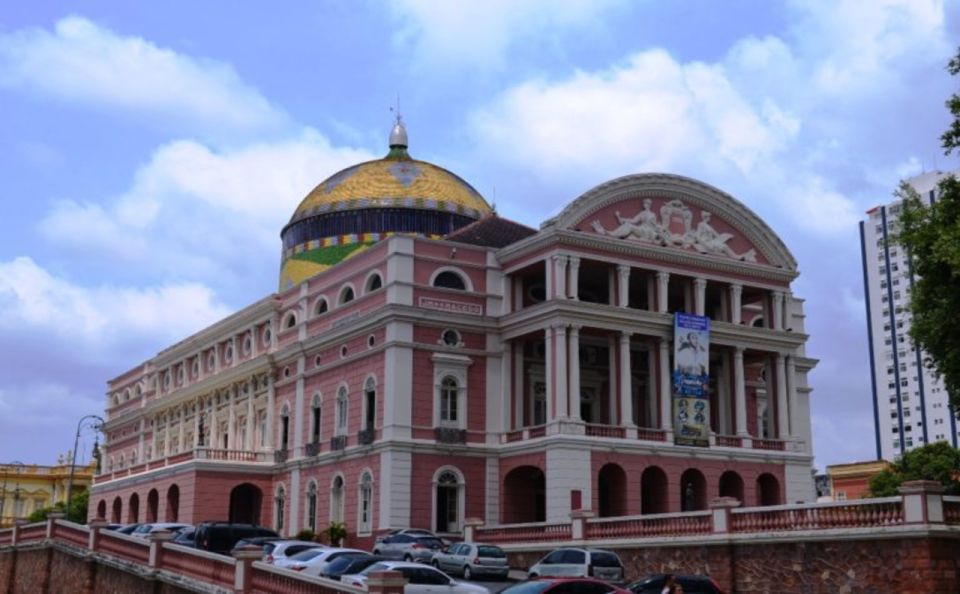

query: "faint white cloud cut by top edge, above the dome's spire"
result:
(390, 0), (622, 68)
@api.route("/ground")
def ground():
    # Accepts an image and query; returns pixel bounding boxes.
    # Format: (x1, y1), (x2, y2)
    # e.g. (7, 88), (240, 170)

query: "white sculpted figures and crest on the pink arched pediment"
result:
(591, 198), (757, 262)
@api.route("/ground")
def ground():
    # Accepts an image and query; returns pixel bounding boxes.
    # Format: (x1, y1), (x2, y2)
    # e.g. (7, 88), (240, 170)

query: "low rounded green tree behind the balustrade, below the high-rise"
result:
(869, 441), (960, 497)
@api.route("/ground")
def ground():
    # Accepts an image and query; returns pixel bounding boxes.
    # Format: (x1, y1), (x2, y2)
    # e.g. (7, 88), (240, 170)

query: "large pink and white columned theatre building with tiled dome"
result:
(90, 124), (816, 546)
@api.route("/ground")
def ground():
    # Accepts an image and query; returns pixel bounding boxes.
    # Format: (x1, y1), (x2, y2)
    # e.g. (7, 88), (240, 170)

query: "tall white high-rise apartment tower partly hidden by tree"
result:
(860, 171), (957, 460)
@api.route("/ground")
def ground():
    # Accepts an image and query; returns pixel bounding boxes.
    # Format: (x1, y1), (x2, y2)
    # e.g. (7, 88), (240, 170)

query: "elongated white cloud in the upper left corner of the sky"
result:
(0, 16), (287, 138)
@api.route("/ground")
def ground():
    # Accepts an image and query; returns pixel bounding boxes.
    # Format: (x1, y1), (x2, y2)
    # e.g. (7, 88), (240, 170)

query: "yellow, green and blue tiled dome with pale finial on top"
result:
(280, 119), (491, 290)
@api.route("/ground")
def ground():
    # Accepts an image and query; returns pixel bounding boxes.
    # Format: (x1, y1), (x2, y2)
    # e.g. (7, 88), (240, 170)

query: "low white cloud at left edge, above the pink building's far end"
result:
(0, 257), (230, 350)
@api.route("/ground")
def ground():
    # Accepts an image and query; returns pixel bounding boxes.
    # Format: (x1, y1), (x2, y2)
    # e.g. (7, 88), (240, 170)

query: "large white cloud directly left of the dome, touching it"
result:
(40, 130), (374, 280)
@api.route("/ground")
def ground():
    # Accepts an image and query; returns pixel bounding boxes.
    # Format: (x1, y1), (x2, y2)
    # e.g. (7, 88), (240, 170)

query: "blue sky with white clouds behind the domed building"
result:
(0, 0), (960, 468)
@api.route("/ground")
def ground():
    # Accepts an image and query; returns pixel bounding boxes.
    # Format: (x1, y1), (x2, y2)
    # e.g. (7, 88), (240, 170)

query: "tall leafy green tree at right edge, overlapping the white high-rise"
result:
(896, 51), (960, 414)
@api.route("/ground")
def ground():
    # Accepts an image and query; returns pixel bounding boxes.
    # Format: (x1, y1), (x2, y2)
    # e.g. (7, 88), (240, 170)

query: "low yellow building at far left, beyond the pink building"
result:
(0, 455), (97, 528)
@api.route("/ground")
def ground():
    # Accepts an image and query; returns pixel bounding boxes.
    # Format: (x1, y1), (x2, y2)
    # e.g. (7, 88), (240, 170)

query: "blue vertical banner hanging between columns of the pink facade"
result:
(673, 312), (710, 447)
